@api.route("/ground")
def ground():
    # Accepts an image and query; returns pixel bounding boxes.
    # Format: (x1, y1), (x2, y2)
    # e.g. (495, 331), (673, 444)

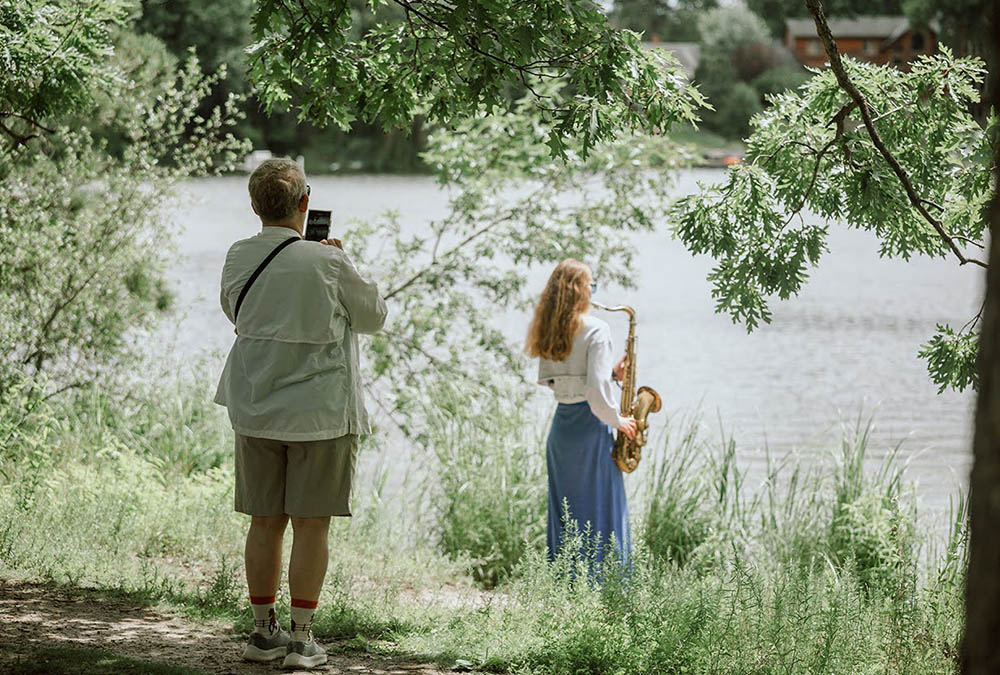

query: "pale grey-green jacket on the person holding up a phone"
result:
(215, 226), (386, 441)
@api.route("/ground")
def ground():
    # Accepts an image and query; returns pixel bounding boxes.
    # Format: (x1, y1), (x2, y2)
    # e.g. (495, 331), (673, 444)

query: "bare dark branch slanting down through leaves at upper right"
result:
(806, 0), (989, 268)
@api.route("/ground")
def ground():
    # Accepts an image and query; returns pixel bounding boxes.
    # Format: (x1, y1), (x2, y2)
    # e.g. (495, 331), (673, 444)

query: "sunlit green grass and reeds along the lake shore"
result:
(0, 382), (966, 673)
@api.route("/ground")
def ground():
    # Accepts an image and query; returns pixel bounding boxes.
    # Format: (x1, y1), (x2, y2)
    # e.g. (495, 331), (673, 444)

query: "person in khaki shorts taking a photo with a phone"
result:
(215, 159), (387, 668)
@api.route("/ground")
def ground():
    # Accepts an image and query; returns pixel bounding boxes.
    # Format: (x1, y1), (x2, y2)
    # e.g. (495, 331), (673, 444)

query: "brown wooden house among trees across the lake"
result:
(785, 16), (937, 70)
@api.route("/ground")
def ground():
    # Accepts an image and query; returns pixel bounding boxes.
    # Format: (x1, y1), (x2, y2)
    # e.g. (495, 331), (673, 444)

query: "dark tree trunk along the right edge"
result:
(962, 0), (1000, 675)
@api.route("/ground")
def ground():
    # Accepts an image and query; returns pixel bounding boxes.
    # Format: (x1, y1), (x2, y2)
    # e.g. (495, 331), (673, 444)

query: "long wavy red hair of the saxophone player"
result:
(524, 258), (592, 361)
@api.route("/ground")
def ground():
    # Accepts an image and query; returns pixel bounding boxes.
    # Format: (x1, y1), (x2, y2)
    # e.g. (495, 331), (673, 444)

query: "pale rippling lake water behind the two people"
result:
(165, 169), (985, 524)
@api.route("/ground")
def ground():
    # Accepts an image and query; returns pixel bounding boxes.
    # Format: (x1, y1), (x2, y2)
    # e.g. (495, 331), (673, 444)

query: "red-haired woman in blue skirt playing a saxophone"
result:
(525, 259), (636, 564)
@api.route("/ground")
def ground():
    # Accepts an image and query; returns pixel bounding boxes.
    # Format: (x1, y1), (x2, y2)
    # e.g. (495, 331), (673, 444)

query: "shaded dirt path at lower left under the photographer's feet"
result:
(0, 579), (466, 675)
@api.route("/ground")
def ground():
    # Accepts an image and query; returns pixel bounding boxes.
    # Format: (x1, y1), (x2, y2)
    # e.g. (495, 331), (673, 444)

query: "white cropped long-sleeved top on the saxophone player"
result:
(538, 314), (625, 429)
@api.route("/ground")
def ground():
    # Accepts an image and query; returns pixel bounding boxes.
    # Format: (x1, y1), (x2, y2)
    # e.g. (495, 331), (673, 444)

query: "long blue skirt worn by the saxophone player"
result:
(546, 401), (632, 576)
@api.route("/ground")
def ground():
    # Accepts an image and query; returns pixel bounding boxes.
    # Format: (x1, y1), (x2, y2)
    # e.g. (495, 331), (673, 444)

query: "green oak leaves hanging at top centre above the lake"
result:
(248, 0), (697, 153)
